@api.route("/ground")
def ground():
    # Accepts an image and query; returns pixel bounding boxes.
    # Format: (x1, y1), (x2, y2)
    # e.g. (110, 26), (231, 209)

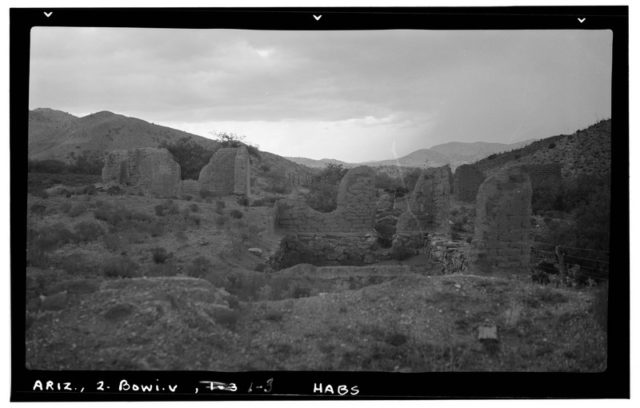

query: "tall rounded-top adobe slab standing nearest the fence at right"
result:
(470, 167), (532, 274)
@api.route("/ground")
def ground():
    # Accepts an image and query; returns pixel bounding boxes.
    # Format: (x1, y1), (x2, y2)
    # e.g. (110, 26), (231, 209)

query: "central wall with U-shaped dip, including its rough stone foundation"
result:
(273, 166), (377, 268)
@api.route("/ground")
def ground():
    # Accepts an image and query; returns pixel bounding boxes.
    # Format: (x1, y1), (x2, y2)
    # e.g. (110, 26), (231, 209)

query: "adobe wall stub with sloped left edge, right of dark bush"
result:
(198, 146), (251, 197)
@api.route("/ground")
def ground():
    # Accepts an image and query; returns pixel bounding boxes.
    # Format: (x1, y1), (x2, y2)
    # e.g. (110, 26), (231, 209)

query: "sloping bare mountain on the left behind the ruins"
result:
(28, 108), (219, 162)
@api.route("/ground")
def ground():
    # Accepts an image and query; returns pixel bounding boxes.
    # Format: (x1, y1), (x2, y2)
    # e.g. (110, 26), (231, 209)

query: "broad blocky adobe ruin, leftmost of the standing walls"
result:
(102, 147), (182, 197)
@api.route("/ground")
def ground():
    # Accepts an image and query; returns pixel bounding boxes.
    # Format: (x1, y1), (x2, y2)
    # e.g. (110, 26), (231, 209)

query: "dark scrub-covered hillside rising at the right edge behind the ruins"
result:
(476, 119), (611, 178)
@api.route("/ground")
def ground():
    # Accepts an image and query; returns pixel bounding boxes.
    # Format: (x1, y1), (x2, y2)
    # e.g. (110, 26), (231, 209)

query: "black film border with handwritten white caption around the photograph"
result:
(10, 6), (630, 401)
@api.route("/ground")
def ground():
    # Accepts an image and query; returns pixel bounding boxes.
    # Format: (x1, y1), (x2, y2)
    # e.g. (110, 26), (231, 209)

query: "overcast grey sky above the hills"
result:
(29, 27), (612, 162)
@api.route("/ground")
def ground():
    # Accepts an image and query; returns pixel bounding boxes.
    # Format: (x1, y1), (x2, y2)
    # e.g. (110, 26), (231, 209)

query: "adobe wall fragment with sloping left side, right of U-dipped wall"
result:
(392, 165), (451, 255)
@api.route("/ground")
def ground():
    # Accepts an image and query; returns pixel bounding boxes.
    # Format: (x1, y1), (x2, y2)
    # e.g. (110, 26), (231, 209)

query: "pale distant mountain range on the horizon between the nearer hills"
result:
(287, 140), (532, 169)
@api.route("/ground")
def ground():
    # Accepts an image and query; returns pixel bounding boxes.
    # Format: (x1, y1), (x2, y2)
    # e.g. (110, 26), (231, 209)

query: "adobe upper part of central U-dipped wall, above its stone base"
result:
(275, 166), (376, 234)
